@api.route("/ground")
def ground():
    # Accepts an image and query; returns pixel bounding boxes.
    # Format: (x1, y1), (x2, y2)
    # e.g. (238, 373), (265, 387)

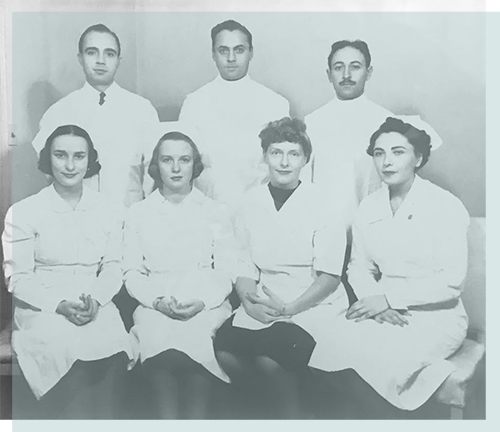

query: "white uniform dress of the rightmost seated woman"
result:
(314, 176), (469, 410)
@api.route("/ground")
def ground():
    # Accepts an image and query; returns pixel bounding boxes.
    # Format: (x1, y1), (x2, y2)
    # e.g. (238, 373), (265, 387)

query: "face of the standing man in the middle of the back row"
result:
(212, 30), (253, 81)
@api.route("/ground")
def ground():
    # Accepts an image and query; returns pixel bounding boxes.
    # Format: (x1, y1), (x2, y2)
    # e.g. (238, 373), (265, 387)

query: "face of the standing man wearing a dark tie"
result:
(78, 32), (120, 87)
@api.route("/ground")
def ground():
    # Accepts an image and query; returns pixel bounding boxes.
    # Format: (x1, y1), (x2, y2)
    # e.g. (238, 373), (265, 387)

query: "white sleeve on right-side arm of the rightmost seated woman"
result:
(380, 203), (469, 309)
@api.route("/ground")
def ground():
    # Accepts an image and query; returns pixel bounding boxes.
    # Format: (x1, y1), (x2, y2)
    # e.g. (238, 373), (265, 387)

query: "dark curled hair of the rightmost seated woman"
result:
(366, 117), (432, 170)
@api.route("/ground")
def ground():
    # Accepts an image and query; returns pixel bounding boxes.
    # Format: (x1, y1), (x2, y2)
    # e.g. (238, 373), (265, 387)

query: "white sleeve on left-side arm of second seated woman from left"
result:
(123, 207), (163, 309)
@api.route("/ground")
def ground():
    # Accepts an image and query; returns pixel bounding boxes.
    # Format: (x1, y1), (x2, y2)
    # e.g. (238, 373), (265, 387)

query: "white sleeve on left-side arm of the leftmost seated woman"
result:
(2, 207), (65, 313)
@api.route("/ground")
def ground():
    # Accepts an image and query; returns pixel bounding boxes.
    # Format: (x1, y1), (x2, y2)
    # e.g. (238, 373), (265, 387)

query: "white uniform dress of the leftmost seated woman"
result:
(2, 186), (134, 398)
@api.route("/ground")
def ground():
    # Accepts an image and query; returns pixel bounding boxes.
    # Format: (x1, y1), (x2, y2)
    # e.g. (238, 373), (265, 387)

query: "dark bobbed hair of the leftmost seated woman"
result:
(38, 125), (101, 178)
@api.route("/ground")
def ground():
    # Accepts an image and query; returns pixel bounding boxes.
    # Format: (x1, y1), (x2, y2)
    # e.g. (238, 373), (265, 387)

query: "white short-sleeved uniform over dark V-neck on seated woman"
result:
(233, 182), (348, 367)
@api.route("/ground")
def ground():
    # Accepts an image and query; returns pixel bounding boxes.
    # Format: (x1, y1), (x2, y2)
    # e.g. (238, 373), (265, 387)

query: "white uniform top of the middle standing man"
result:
(179, 75), (290, 211)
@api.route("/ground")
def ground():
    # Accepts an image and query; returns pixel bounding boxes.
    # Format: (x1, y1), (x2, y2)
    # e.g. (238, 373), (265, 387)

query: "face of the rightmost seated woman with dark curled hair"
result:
(373, 132), (422, 186)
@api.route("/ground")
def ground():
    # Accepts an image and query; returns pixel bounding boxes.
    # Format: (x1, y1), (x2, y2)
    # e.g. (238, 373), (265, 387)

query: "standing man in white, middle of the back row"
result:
(179, 20), (290, 208)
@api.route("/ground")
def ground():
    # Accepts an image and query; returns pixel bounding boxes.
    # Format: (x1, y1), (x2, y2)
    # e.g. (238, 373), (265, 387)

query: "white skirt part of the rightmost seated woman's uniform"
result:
(316, 305), (468, 410)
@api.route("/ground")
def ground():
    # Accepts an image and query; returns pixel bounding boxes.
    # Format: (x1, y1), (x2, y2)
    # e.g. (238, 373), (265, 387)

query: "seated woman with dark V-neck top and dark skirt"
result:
(215, 117), (348, 419)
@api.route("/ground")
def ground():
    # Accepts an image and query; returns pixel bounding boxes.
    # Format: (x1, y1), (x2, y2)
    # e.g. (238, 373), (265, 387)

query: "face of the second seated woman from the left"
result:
(158, 140), (194, 193)
